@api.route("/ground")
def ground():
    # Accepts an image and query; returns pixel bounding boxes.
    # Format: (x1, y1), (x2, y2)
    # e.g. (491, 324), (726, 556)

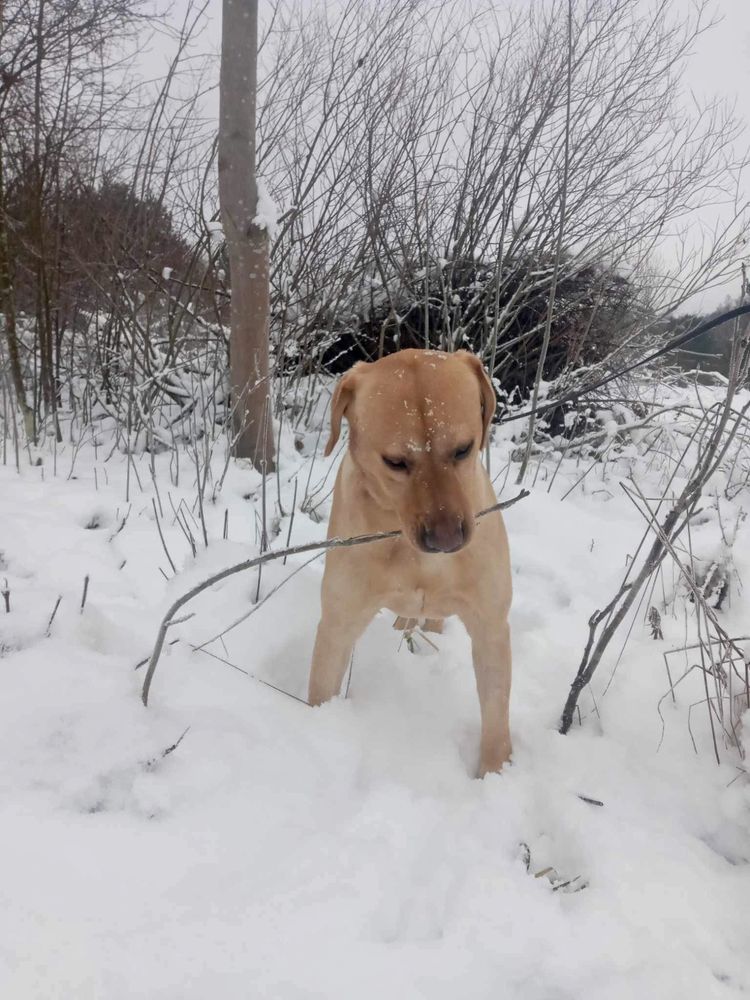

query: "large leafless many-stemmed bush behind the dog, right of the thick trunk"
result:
(258, 0), (746, 402)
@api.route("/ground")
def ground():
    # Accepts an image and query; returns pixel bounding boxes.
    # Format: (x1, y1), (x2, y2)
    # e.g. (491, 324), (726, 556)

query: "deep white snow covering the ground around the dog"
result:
(0, 392), (750, 1000)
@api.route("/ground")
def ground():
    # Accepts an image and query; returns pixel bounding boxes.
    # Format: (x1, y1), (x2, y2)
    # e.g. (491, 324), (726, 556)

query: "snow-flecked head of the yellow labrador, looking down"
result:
(325, 350), (495, 552)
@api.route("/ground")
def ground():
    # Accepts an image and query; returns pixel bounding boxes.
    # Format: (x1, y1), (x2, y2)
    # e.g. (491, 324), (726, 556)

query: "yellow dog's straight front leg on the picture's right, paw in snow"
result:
(461, 609), (512, 778)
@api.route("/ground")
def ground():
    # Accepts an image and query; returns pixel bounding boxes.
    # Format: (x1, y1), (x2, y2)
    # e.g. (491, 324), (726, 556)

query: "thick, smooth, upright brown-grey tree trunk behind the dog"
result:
(219, 0), (274, 472)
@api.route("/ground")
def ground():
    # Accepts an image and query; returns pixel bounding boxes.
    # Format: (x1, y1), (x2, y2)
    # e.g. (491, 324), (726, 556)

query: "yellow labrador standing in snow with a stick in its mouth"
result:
(309, 350), (511, 776)
